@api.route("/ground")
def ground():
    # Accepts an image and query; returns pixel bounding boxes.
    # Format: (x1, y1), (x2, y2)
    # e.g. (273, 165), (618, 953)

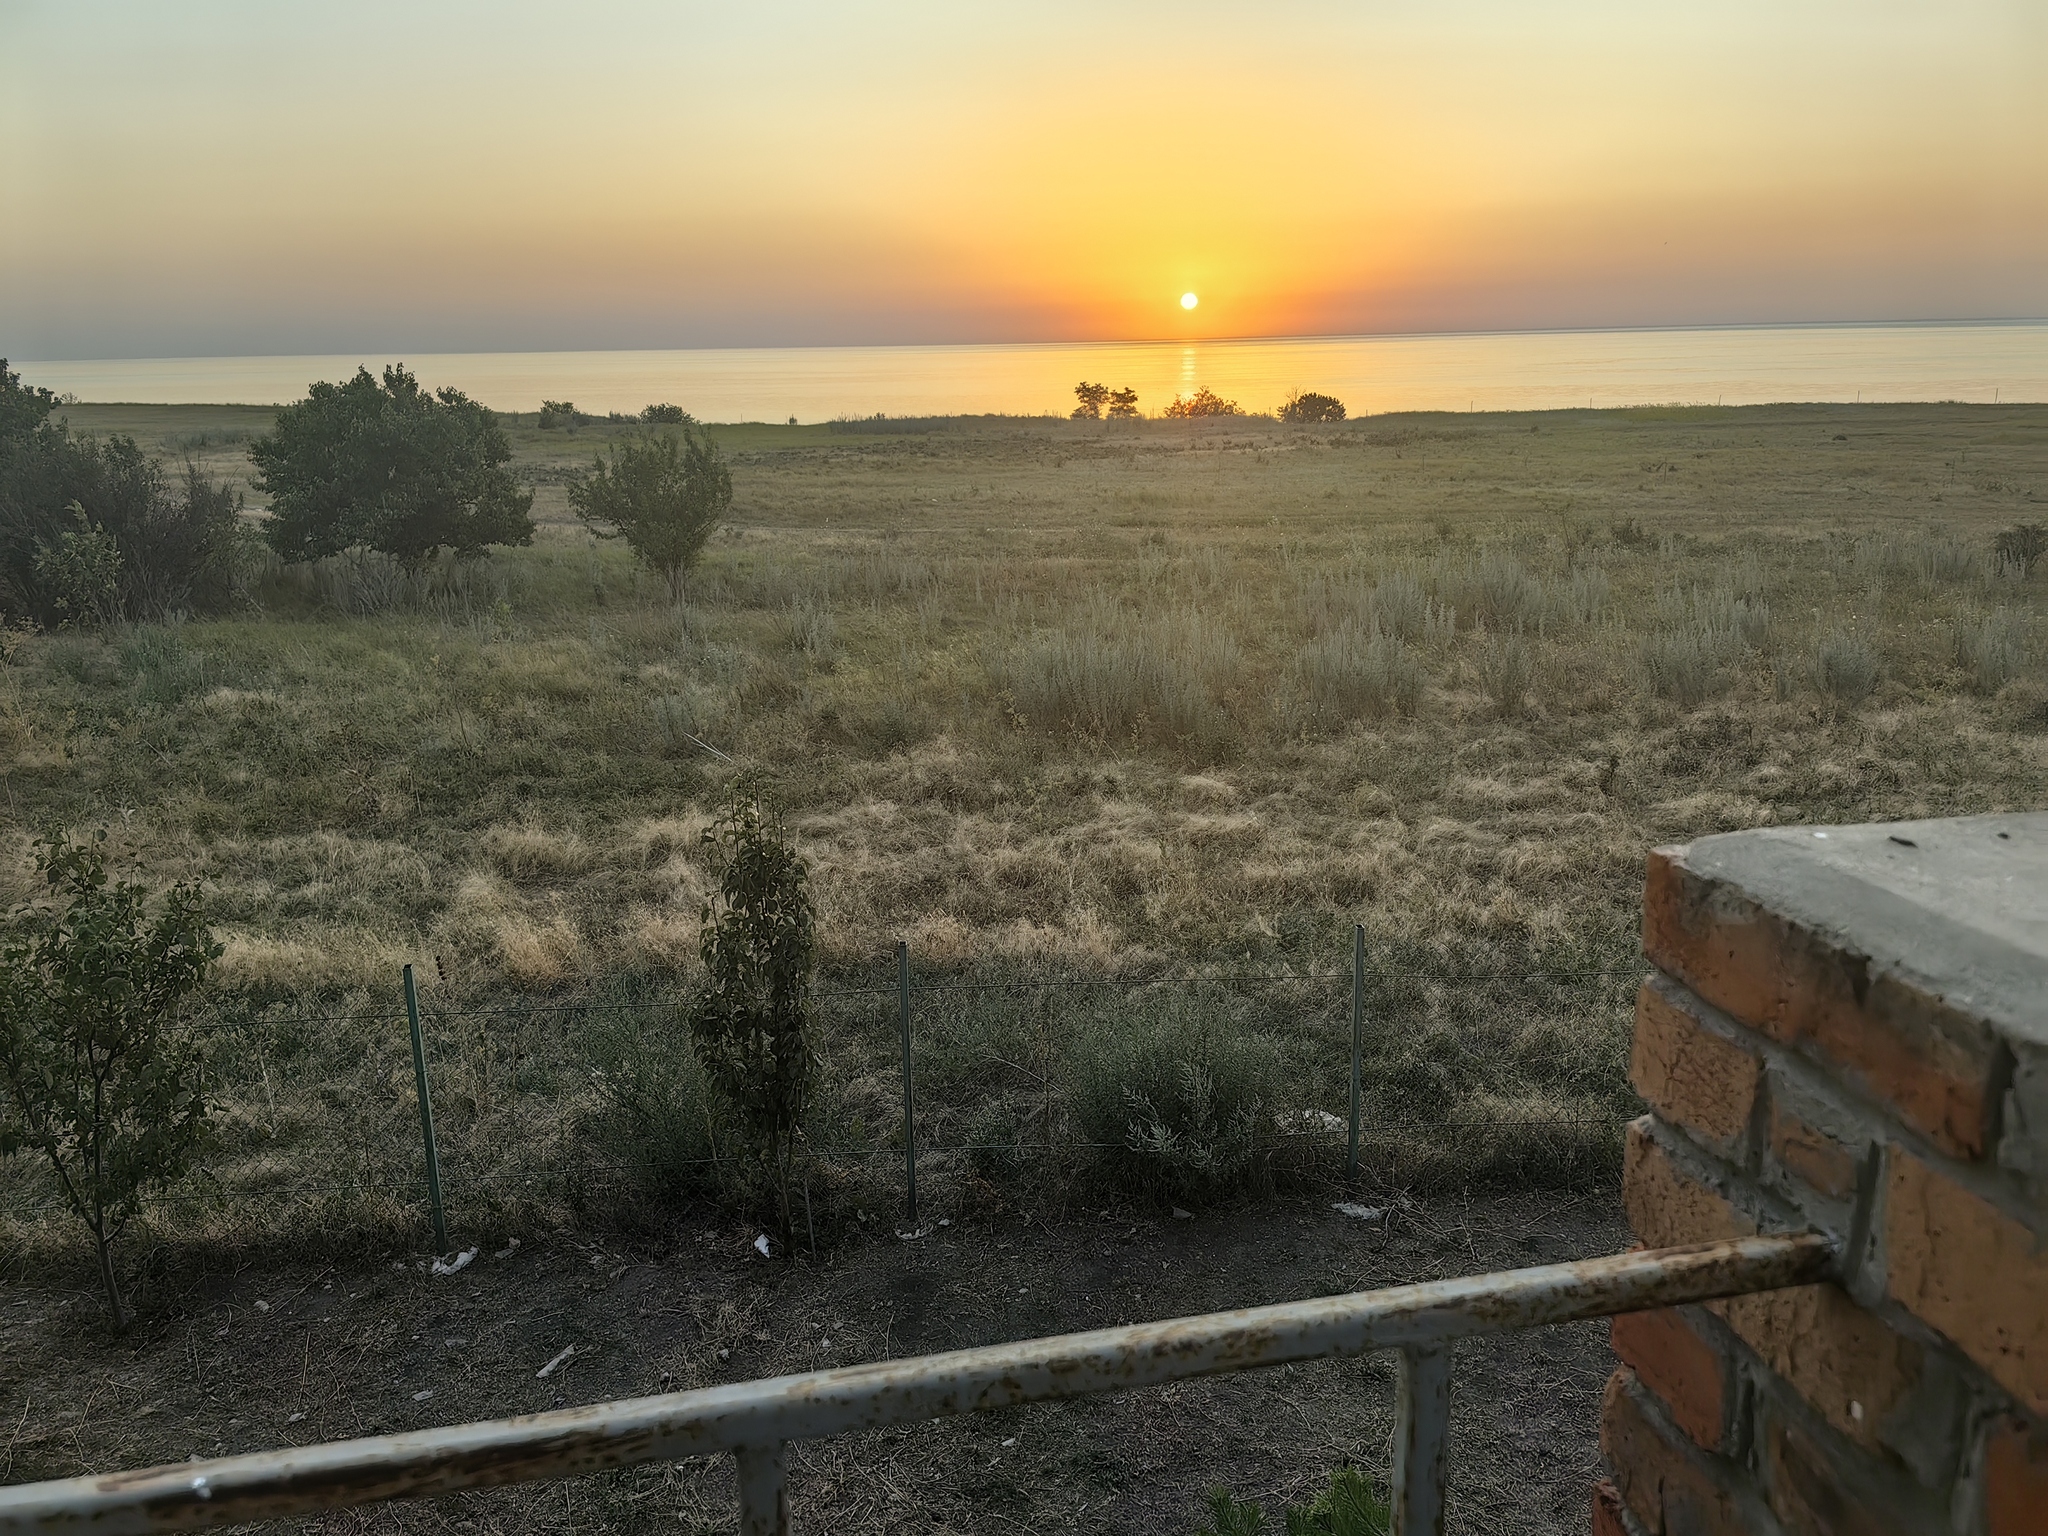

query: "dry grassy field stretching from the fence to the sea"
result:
(0, 406), (2048, 1241)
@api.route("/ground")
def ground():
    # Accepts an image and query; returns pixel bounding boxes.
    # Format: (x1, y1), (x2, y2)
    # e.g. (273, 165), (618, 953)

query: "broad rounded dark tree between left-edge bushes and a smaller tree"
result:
(250, 367), (532, 569)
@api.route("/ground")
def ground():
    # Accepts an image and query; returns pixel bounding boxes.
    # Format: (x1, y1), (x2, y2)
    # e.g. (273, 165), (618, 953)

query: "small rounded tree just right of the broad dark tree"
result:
(569, 428), (733, 602)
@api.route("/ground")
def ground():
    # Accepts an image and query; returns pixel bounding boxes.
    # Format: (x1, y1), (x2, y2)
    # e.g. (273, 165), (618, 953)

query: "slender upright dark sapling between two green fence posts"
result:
(690, 780), (817, 1247)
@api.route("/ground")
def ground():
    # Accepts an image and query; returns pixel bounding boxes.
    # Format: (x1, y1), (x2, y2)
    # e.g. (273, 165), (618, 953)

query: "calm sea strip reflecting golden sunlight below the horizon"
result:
(14, 322), (2048, 422)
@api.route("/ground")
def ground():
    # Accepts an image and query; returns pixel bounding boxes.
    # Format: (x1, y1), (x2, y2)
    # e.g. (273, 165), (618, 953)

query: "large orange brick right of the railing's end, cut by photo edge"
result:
(1884, 1147), (2048, 1413)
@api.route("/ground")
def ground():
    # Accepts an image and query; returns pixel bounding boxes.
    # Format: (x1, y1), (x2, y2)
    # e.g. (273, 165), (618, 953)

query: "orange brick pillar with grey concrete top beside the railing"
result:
(1593, 813), (2048, 1536)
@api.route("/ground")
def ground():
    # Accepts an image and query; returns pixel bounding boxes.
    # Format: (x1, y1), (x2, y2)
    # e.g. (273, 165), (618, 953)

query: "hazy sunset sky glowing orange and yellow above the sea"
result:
(0, 0), (2048, 360)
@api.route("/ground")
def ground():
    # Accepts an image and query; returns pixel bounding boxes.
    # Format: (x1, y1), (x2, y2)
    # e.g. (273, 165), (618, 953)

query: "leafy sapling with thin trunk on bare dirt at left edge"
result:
(0, 831), (221, 1331)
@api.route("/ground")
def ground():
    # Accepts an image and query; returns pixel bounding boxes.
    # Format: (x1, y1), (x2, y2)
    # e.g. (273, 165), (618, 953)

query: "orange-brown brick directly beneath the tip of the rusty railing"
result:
(1706, 1284), (1925, 1450)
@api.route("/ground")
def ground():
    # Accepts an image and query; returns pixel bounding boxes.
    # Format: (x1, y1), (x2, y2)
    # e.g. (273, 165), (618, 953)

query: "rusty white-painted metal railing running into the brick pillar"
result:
(0, 1233), (1835, 1536)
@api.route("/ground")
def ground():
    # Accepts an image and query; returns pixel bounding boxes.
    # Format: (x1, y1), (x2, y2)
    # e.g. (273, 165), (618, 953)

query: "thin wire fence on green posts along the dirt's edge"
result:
(0, 942), (1640, 1231)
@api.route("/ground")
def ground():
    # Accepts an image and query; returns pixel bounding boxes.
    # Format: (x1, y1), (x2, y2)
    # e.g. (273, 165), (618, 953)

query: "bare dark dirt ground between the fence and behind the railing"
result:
(0, 1194), (1626, 1536)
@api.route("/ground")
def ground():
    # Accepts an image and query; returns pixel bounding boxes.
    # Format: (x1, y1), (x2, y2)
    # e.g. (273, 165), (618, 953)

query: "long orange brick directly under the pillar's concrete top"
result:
(1642, 848), (1999, 1157)
